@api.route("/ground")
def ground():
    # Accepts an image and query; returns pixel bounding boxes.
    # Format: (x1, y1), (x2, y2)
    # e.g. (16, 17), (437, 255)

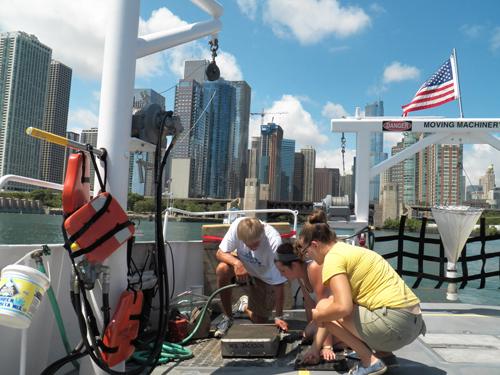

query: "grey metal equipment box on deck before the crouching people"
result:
(221, 324), (280, 358)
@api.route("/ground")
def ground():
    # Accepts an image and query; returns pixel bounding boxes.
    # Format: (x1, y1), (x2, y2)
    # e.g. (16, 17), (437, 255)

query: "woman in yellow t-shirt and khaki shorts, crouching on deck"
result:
(296, 211), (425, 375)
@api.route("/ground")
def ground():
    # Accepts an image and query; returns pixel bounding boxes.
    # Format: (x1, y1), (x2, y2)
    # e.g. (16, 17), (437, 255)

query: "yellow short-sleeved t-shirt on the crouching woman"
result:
(322, 242), (420, 311)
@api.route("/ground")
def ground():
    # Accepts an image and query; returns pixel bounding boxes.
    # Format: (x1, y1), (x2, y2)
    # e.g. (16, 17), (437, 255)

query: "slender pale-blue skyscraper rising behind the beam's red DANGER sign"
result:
(365, 100), (387, 202)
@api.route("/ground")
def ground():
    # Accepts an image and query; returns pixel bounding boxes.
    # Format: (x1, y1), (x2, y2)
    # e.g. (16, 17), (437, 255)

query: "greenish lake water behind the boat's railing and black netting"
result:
(0, 213), (500, 305)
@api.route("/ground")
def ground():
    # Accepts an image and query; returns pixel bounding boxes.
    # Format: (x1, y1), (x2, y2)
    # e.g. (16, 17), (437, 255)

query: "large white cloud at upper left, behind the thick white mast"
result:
(0, 0), (241, 79)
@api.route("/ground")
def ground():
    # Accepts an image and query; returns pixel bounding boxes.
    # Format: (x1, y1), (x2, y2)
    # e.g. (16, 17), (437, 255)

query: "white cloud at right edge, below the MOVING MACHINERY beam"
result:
(463, 144), (500, 186)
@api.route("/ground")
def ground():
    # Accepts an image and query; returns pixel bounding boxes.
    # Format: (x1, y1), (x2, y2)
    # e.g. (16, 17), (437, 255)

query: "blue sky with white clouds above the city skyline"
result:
(0, 0), (500, 185)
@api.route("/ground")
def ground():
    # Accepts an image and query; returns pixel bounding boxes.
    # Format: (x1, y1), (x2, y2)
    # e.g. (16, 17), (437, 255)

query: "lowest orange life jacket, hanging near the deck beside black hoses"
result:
(102, 290), (143, 367)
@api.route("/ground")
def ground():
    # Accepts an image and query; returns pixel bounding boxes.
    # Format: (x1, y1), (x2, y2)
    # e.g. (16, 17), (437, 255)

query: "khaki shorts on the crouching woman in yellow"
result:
(353, 305), (425, 352)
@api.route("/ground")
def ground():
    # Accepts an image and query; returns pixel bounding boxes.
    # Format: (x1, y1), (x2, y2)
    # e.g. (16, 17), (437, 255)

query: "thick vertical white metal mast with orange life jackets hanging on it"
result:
(85, 0), (140, 374)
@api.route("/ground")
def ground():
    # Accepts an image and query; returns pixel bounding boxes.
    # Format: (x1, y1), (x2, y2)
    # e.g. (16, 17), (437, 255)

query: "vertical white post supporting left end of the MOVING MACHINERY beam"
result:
(354, 130), (371, 223)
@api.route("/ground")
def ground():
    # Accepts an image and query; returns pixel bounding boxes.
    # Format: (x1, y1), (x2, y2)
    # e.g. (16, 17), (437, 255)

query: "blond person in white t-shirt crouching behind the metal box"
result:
(215, 217), (288, 337)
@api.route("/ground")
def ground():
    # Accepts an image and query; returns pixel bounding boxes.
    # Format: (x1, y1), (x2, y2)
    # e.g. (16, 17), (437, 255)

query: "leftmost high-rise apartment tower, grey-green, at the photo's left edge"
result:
(0, 31), (52, 188)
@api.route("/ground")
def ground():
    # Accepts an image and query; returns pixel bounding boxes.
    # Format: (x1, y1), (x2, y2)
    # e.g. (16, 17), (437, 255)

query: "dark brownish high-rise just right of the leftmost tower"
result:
(40, 60), (72, 184)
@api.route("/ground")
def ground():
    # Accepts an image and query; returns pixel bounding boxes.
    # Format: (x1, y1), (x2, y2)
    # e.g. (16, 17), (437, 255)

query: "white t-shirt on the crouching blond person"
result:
(219, 218), (286, 285)
